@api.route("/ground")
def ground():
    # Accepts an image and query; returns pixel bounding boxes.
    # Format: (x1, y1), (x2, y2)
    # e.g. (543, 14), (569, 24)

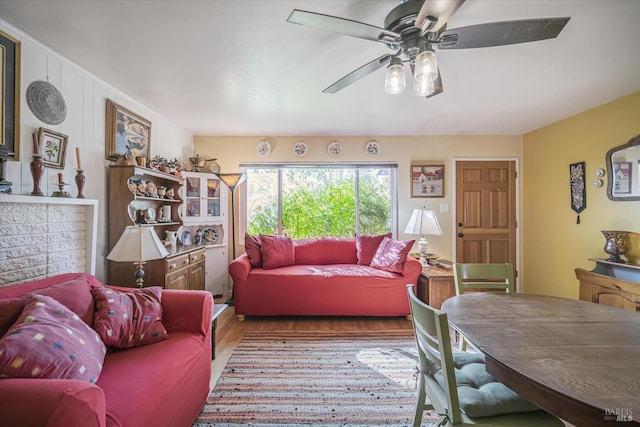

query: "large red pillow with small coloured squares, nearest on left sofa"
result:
(0, 294), (106, 383)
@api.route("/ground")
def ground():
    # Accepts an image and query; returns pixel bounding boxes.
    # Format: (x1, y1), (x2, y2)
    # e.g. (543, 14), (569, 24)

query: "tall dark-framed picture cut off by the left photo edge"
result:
(0, 31), (20, 160)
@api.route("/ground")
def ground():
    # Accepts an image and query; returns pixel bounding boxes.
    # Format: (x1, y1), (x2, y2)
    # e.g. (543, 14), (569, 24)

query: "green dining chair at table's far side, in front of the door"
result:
(453, 263), (515, 351)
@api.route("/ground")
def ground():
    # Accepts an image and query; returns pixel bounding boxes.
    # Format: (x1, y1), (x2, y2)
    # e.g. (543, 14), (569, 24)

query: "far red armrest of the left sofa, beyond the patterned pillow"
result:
(162, 289), (213, 338)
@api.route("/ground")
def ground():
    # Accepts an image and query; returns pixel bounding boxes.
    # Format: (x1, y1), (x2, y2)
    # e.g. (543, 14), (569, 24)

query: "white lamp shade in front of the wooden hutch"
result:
(107, 225), (169, 262)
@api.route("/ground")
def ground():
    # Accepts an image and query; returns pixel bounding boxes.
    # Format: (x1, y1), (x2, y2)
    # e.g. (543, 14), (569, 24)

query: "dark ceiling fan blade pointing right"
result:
(438, 17), (570, 49)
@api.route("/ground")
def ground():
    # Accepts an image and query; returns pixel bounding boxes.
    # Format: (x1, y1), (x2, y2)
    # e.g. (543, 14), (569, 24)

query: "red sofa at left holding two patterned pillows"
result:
(0, 273), (213, 427)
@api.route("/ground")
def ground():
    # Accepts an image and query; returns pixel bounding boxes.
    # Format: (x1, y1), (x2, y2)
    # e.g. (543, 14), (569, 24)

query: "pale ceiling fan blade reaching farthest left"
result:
(287, 9), (399, 42)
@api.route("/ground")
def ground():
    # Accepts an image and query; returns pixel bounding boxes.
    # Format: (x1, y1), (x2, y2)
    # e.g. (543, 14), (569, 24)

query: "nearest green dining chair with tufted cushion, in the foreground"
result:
(407, 284), (564, 427)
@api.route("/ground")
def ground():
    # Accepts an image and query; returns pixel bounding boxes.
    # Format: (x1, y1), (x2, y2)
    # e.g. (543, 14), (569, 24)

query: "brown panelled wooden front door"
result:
(456, 161), (517, 269)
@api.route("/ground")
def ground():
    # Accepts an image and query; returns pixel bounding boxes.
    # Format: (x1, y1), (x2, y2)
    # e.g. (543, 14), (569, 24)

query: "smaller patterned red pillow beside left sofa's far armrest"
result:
(91, 286), (169, 348)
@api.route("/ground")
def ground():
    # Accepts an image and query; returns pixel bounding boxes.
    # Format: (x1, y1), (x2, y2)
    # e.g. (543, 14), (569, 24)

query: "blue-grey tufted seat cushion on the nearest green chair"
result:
(432, 353), (539, 417)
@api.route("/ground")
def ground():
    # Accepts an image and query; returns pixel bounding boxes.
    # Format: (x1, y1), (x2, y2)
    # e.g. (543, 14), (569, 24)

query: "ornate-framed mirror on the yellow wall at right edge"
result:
(606, 135), (640, 200)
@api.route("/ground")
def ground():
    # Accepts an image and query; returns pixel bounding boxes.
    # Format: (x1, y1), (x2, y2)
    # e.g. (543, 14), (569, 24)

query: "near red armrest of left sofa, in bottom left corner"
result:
(0, 378), (106, 427)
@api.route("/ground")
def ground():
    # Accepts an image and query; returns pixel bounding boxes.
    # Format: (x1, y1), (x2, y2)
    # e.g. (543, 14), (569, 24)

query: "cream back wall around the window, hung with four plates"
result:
(194, 135), (522, 259)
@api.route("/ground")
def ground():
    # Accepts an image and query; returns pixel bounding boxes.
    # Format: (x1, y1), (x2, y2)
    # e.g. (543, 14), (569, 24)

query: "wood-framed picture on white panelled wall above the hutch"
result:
(105, 99), (151, 163)
